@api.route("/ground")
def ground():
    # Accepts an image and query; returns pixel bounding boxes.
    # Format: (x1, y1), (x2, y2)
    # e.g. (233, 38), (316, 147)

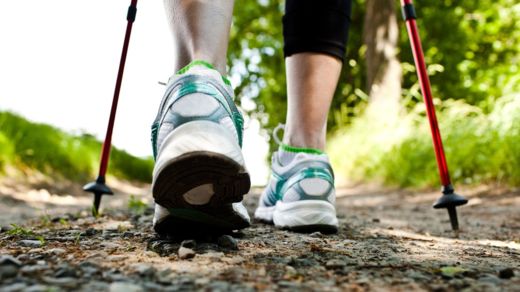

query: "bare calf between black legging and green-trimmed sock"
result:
(283, 52), (342, 150)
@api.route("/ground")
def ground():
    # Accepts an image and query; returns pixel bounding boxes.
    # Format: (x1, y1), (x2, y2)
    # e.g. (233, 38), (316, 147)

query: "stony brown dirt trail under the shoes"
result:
(0, 187), (520, 291)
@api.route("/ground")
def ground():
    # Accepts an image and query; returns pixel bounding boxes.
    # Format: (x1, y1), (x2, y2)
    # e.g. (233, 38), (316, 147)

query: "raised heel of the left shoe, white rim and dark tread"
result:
(152, 121), (251, 208)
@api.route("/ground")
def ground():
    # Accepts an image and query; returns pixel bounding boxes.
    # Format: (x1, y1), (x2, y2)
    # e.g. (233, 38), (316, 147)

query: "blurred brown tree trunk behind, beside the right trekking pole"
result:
(363, 0), (401, 119)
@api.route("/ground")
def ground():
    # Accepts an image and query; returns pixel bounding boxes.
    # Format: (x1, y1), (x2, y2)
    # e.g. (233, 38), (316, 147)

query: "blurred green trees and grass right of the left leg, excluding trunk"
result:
(229, 0), (520, 186)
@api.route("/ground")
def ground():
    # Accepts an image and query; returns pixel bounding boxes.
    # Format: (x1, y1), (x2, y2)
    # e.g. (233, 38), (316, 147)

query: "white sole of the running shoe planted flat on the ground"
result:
(255, 200), (338, 234)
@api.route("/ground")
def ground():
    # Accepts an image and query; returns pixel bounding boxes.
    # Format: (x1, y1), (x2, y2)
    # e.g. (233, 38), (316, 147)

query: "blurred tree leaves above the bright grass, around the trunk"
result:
(228, 0), (520, 132)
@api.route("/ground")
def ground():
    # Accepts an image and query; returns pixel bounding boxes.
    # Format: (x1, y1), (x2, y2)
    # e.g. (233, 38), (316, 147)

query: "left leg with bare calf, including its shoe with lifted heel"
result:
(152, 0), (250, 236)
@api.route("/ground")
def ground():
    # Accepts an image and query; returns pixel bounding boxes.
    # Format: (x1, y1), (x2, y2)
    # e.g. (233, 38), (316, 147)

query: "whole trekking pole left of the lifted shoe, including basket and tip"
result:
(83, 0), (137, 216)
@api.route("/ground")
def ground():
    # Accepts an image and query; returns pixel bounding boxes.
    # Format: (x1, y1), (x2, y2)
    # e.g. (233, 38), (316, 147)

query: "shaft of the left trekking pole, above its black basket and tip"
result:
(99, 0), (137, 177)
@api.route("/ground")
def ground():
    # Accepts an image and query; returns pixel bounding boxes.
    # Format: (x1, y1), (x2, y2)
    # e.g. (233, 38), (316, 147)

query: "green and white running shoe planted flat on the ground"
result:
(255, 125), (338, 233)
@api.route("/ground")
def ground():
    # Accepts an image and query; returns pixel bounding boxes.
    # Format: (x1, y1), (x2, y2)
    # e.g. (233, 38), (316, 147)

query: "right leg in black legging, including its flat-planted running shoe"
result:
(255, 0), (351, 233)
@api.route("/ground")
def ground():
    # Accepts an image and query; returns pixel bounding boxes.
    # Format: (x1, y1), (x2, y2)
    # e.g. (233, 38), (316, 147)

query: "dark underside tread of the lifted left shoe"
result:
(152, 151), (251, 234)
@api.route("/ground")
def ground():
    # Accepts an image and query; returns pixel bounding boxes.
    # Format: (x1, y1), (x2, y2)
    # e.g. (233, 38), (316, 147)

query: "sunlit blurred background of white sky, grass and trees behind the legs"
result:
(0, 0), (520, 188)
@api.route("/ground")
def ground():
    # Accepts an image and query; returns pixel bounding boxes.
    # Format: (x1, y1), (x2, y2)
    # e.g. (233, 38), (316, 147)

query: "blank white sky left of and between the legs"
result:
(0, 0), (268, 185)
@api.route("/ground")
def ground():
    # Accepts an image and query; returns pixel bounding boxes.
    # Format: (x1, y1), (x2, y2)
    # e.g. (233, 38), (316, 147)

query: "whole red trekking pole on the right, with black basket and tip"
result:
(401, 0), (468, 230)
